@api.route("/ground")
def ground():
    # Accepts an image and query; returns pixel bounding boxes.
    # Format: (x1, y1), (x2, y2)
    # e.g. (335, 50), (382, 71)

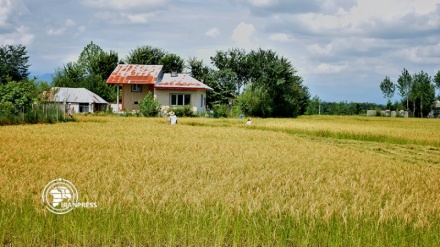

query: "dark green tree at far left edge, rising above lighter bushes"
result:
(0, 45), (30, 84)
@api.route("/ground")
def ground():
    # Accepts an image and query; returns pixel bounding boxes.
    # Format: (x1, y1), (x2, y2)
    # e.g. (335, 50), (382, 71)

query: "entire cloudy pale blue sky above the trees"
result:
(0, 0), (440, 103)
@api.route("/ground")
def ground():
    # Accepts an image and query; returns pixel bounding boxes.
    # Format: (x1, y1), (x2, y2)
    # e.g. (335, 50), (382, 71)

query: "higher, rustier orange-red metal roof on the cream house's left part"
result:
(107, 64), (163, 84)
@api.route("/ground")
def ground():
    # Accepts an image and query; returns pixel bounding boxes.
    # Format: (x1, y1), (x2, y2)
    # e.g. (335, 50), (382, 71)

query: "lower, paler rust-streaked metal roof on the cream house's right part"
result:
(154, 73), (213, 90)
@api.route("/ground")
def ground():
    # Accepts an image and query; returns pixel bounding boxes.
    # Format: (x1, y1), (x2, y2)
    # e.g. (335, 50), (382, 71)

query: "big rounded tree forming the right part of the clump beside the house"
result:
(239, 49), (310, 117)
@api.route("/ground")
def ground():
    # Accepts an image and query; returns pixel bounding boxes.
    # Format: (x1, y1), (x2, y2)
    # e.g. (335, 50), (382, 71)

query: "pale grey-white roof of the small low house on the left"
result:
(52, 87), (107, 104)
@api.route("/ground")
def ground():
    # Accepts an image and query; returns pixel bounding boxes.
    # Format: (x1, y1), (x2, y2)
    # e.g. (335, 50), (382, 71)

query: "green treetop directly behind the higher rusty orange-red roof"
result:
(124, 45), (167, 65)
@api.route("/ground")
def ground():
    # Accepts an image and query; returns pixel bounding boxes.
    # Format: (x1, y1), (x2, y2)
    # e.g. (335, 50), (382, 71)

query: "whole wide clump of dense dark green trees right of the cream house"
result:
(208, 49), (310, 117)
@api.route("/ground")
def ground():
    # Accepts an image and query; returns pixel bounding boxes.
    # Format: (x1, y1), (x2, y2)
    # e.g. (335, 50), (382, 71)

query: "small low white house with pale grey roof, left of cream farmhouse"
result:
(46, 87), (108, 113)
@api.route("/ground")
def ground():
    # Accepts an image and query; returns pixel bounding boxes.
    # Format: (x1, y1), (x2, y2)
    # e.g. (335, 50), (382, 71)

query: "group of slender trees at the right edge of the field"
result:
(379, 68), (440, 117)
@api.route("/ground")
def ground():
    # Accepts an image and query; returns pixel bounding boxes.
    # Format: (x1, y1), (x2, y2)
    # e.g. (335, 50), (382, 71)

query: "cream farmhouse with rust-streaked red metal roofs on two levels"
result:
(107, 64), (213, 113)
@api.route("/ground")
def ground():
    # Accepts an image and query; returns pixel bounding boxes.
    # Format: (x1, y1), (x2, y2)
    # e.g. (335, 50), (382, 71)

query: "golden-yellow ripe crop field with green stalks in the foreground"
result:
(0, 115), (440, 246)
